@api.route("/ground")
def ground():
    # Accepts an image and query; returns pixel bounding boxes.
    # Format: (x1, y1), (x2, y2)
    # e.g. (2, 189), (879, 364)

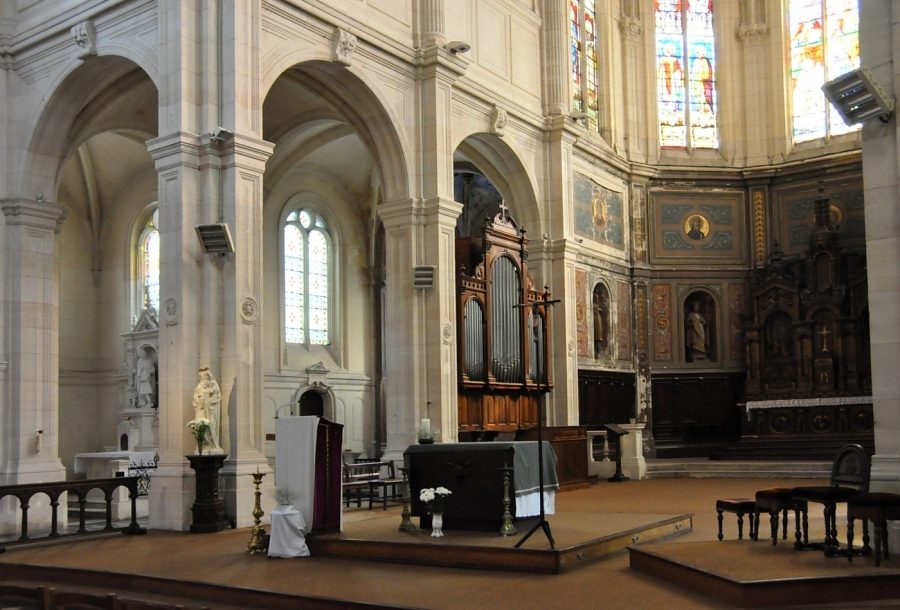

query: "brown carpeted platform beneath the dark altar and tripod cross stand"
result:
(307, 511), (692, 574)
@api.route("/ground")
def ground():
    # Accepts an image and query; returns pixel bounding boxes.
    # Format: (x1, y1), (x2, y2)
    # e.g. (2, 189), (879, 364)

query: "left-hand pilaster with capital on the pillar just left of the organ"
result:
(378, 200), (426, 462)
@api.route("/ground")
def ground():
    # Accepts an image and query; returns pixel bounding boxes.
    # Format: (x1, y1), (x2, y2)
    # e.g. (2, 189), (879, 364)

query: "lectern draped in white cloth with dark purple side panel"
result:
(275, 415), (344, 533)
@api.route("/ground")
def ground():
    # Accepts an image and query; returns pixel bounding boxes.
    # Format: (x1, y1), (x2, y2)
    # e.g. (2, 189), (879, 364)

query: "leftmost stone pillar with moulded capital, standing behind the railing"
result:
(0, 199), (66, 533)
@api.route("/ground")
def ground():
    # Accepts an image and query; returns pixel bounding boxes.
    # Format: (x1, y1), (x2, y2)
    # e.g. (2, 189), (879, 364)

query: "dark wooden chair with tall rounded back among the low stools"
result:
(791, 445), (869, 557)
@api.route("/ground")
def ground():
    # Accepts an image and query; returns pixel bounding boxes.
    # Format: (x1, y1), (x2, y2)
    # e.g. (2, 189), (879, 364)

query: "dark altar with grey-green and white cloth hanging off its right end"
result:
(404, 441), (559, 531)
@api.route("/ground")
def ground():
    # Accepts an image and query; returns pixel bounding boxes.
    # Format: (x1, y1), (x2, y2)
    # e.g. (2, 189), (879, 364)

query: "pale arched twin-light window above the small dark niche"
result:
(283, 209), (331, 345)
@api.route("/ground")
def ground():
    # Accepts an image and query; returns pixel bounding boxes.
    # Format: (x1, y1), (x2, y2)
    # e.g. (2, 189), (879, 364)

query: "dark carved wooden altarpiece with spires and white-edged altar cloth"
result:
(741, 197), (873, 459)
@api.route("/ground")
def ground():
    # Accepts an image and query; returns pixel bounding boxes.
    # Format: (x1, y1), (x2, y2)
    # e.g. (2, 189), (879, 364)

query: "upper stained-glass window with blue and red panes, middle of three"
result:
(656, 0), (719, 148)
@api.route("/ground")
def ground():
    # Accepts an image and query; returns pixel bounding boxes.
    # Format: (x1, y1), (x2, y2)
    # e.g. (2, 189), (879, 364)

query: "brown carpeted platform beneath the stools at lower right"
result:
(628, 540), (900, 608)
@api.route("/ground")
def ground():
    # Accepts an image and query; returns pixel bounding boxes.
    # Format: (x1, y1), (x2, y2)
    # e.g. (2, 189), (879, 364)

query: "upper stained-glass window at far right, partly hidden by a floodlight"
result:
(790, 0), (859, 142)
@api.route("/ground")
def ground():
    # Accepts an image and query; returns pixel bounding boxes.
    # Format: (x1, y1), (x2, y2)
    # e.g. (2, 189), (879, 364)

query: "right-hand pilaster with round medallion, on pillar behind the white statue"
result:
(218, 134), (273, 527)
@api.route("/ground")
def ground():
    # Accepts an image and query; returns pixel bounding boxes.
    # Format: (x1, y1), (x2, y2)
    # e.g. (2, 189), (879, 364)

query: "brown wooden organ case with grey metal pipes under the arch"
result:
(456, 203), (553, 440)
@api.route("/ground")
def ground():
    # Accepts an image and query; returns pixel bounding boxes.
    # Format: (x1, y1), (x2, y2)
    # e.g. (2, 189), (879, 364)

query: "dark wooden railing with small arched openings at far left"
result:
(0, 477), (147, 552)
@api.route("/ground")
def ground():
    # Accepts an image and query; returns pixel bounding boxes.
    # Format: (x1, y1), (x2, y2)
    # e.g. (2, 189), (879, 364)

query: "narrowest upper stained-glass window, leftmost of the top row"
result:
(569, 0), (600, 131)
